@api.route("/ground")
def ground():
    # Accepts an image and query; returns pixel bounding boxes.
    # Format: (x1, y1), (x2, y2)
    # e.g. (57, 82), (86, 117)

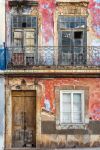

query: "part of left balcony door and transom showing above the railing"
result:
(12, 15), (37, 47)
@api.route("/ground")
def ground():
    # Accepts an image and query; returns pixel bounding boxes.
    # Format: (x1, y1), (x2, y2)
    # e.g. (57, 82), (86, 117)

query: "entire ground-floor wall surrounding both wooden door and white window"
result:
(5, 77), (100, 148)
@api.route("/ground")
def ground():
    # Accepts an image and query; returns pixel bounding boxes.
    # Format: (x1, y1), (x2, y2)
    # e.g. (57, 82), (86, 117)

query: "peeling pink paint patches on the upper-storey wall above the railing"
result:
(6, 0), (100, 46)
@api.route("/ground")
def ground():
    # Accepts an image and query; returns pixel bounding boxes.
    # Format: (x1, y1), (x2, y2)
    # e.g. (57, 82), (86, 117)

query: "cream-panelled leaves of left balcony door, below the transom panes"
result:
(12, 29), (36, 66)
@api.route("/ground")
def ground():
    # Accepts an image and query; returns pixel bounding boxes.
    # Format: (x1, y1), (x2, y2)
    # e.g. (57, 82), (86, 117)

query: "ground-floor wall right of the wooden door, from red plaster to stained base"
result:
(39, 78), (100, 148)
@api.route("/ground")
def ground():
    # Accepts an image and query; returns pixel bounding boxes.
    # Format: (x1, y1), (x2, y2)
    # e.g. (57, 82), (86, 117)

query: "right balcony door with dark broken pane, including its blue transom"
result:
(58, 16), (87, 65)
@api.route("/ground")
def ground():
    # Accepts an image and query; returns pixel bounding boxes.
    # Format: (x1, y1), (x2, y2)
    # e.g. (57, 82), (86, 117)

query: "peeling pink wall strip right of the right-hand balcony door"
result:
(88, 0), (100, 50)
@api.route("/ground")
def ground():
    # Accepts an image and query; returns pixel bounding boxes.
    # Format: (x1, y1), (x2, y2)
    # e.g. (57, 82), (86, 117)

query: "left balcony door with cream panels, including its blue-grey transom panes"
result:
(11, 15), (38, 66)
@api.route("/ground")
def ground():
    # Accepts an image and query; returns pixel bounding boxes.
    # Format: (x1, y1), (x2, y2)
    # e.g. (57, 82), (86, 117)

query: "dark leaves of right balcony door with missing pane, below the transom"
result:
(59, 30), (86, 65)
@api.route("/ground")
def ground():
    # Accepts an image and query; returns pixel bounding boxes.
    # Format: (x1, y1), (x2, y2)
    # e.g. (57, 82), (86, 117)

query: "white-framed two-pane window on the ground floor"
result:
(60, 90), (84, 124)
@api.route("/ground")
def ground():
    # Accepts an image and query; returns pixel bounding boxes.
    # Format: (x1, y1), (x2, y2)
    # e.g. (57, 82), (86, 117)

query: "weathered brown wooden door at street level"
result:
(12, 91), (36, 147)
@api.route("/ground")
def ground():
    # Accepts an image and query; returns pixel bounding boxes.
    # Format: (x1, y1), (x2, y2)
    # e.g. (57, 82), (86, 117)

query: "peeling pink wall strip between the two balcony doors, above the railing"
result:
(39, 0), (55, 46)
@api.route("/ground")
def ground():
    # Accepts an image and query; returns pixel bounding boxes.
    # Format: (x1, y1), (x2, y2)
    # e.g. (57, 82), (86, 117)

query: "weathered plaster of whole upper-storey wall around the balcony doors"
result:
(6, 0), (100, 65)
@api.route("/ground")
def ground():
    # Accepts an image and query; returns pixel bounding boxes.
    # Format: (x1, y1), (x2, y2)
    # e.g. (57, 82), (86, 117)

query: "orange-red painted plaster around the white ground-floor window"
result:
(41, 78), (100, 120)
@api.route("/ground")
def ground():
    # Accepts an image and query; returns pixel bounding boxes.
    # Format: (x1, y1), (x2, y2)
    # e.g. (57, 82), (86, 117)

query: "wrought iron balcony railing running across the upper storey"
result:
(5, 46), (100, 69)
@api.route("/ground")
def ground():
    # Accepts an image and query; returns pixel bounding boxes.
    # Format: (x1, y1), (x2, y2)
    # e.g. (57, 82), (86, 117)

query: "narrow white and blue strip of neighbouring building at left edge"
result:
(0, 0), (5, 150)
